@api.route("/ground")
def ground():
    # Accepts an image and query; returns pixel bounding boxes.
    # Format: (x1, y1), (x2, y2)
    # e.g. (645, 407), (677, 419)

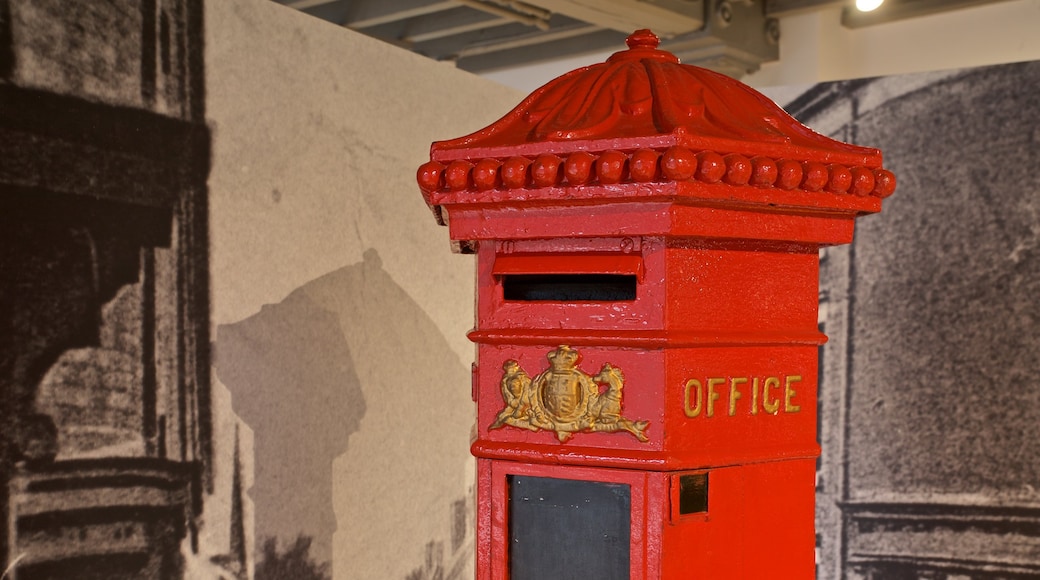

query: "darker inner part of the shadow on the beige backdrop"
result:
(214, 265), (368, 561)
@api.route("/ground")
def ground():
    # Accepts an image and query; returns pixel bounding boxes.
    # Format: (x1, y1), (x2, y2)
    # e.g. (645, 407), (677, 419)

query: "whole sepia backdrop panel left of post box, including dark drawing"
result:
(0, 0), (522, 580)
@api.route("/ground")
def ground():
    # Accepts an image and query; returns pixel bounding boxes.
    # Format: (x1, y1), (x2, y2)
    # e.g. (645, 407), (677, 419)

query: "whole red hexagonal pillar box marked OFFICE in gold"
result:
(418, 31), (894, 580)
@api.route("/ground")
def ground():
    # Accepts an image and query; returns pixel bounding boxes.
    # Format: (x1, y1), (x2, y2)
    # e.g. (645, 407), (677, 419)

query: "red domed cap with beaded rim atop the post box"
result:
(417, 30), (895, 227)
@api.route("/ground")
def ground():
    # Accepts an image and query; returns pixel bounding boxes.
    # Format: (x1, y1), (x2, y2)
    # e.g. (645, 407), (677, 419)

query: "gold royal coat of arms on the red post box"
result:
(489, 345), (648, 443)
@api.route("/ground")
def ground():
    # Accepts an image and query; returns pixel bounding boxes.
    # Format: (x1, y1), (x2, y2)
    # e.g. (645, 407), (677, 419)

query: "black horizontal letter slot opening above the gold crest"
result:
(502, 273), (638, 302)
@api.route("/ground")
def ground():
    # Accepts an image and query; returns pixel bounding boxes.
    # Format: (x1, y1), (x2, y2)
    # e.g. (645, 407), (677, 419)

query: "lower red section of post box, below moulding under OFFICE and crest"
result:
(476, 458), (815, 580)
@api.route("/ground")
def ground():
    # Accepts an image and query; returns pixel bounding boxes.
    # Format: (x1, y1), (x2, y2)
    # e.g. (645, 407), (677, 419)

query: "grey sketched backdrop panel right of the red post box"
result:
(766, 62), (1040, 580)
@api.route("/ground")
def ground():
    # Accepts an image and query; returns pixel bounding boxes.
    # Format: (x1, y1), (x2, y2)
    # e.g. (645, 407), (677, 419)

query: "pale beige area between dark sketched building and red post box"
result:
(206, 0), (522, 580)
